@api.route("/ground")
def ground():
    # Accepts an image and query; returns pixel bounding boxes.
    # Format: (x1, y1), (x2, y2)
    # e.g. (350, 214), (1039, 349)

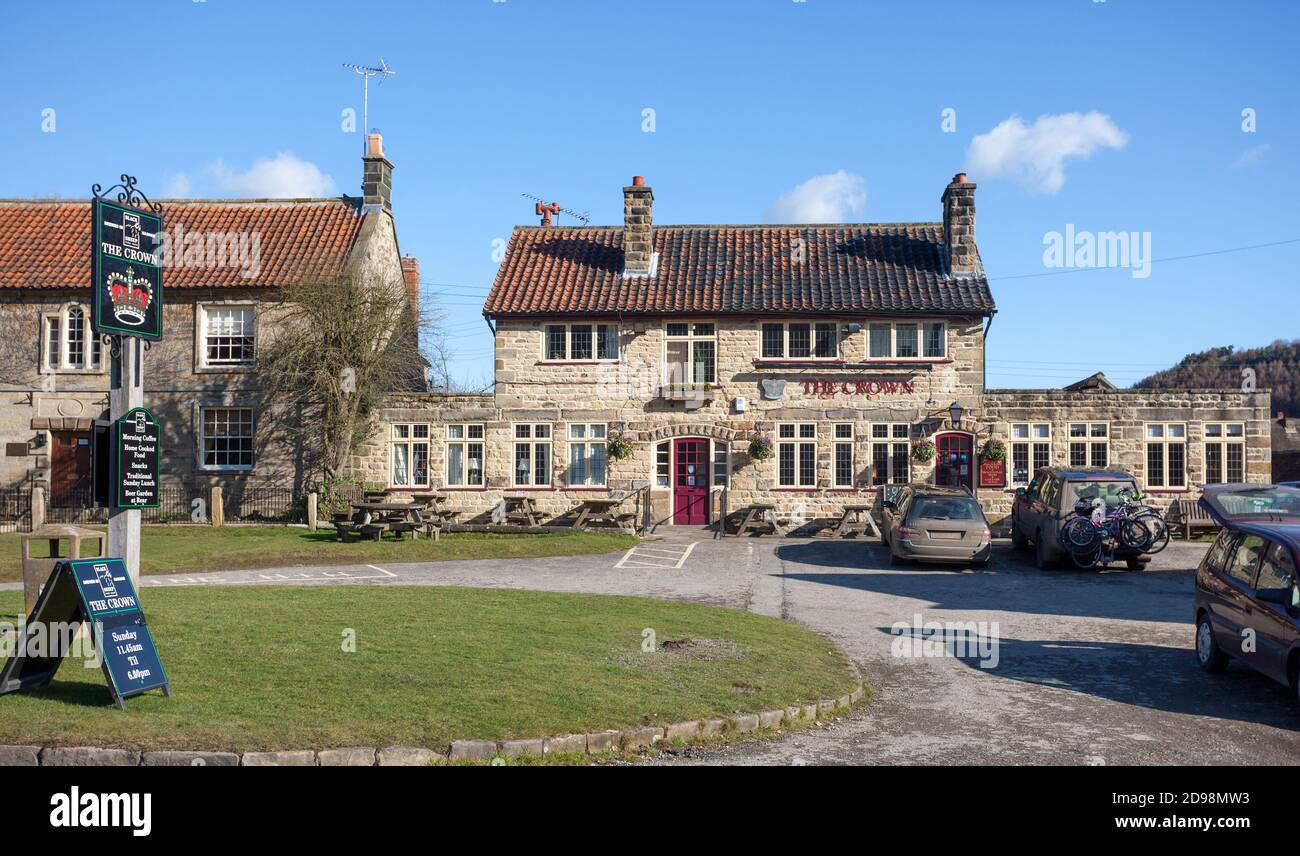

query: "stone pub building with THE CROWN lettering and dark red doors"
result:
(356, 174), (1271, 526)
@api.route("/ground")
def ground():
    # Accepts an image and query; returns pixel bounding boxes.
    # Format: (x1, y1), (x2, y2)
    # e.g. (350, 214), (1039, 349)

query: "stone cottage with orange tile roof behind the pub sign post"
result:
(0, 134), (419, 507)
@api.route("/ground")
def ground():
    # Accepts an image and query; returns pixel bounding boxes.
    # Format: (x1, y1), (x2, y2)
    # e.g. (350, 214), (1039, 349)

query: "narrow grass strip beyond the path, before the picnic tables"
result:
(0, 526), (637, 582)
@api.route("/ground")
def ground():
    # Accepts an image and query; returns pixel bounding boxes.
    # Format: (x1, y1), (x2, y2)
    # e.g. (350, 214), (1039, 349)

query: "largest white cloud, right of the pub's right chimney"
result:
(966, 111), (1128, 194)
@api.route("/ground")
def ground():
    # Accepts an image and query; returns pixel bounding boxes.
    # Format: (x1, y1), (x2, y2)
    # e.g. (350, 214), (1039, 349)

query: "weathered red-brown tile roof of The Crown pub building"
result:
(484, 222), (996, 317)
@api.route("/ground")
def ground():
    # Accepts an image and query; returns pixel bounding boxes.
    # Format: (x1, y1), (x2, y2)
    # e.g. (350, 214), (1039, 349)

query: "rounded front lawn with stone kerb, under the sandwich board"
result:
(0, 585), (855, 749)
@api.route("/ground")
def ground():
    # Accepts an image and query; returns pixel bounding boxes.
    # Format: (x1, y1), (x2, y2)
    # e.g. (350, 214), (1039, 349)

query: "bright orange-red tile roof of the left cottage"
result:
(0, 199), (363, 289)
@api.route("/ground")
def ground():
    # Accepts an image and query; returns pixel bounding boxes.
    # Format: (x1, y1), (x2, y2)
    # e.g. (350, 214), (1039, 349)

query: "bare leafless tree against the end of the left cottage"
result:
(257, 271), (434, 479)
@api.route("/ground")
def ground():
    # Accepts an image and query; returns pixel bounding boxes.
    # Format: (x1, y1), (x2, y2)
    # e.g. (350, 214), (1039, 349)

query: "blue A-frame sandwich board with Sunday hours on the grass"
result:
(0, 558), (172, 710)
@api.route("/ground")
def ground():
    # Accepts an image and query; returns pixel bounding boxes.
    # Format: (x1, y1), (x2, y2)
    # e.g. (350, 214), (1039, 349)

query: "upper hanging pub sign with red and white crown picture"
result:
(90, 176), (163, 340)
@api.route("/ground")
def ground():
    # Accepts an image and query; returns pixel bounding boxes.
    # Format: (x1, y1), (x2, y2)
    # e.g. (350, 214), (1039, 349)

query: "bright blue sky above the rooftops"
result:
(0, 0), (1300, 386)
